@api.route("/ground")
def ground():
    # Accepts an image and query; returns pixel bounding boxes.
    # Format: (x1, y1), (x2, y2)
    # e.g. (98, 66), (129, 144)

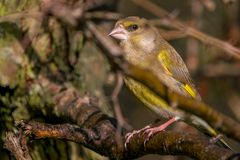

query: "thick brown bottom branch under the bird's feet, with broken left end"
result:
(15, 120), (233, 160)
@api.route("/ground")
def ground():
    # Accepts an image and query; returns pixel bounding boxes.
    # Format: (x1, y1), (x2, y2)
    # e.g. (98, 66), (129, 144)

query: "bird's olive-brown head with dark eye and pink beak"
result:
(109, 16), (149, 40)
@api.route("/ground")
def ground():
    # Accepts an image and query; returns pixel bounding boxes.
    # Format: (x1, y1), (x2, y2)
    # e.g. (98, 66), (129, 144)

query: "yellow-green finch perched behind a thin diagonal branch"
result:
(109, 16), (230, 148)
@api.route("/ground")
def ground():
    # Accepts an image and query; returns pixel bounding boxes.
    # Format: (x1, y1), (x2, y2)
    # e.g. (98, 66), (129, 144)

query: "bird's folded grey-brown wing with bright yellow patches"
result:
(157, 45), (198, 98)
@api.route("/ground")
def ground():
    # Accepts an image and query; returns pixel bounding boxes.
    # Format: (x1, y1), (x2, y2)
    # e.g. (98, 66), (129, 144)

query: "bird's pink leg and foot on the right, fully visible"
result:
(144, 116), (180, 146)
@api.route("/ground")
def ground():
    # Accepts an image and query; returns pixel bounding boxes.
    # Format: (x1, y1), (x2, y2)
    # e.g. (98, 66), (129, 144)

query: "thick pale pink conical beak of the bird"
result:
(108, 25), (128, 40)
